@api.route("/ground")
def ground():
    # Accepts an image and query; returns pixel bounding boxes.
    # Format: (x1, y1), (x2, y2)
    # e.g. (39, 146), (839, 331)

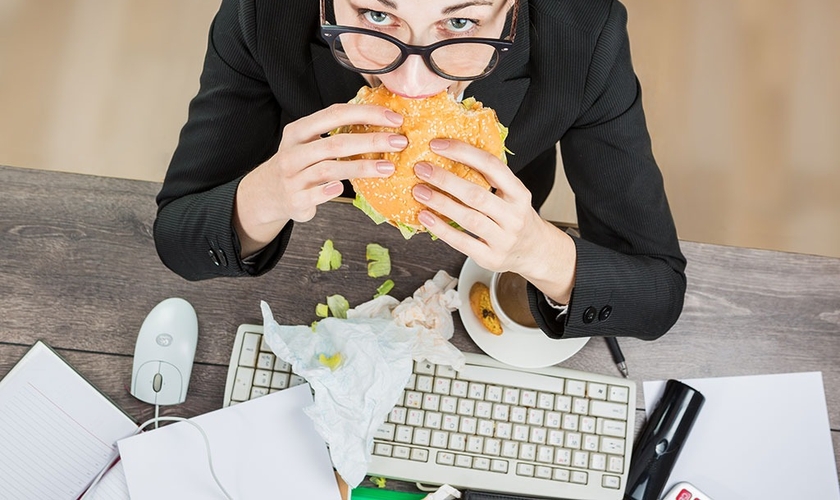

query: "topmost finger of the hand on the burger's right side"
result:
(429, 139), (530, 200)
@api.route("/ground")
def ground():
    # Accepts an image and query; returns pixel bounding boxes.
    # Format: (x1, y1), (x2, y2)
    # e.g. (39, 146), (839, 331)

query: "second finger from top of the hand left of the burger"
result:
(294, 132), (408, 172)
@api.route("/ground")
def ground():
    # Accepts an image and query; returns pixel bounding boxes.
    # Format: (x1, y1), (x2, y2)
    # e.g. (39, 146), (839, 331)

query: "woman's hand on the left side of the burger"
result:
(233, 104), (408, 257)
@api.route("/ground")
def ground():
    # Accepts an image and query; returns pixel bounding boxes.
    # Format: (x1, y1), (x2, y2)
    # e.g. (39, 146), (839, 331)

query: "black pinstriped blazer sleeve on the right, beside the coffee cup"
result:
(529, 1), (686, 339)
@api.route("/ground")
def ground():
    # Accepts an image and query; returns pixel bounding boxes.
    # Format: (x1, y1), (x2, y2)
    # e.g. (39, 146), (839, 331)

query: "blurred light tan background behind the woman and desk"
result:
(0, 0), (840, 257)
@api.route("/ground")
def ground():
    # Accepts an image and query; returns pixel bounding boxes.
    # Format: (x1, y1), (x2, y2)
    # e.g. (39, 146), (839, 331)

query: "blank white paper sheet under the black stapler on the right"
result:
(644, 372), (840, 500)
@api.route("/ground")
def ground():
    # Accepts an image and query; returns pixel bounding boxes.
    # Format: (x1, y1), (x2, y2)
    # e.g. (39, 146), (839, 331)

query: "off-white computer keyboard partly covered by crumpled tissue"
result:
(224, 325), (636, 500)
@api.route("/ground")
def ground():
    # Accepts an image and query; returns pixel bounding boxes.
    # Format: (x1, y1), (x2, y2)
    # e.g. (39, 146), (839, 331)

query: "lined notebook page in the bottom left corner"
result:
(0, 342), (137, 500)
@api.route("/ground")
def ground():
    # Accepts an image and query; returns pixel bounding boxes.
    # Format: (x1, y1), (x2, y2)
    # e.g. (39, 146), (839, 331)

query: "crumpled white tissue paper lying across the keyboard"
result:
(260, 271), (464, 488)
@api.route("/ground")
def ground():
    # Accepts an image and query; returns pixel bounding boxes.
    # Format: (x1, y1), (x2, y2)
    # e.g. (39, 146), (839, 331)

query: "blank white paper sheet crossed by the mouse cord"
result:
(118, 384), (341, 500)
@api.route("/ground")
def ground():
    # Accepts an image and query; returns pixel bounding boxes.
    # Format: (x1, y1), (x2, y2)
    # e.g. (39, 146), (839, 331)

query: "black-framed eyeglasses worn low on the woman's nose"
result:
(321, 0), (518, 81)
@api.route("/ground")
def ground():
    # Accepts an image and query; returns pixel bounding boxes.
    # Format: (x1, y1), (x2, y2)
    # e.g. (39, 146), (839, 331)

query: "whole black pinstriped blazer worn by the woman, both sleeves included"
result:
(154, 0), (685, 339)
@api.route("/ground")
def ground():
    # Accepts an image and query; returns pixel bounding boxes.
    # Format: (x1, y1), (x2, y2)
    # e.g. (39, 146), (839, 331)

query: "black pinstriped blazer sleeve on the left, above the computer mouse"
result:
(154, 0), (292, 280)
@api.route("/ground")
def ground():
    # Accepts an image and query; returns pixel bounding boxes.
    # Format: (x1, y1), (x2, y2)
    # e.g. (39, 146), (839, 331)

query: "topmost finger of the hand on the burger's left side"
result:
(283, 104), (403, 144)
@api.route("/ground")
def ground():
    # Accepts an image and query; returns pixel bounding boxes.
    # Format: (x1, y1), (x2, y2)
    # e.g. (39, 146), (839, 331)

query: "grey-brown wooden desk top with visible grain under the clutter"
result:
(0, 166), (840, 488)
